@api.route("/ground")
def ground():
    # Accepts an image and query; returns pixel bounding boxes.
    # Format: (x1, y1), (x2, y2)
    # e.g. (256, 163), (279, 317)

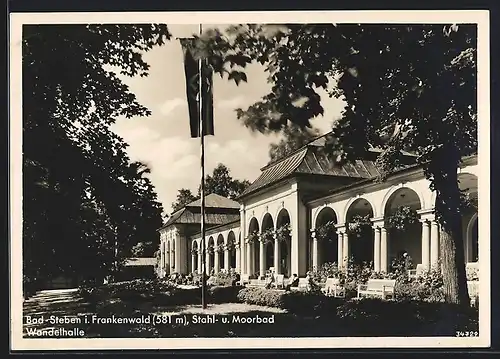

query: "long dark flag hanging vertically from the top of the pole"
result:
(181, 38), (214, 138)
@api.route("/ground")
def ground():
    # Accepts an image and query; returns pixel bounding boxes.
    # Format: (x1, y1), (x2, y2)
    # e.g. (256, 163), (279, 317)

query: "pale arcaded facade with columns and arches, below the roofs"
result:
(160, 157), (478, 277)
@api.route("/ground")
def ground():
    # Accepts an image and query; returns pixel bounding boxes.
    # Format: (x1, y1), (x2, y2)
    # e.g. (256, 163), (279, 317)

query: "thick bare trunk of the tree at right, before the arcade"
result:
(436, 166), (470, 307)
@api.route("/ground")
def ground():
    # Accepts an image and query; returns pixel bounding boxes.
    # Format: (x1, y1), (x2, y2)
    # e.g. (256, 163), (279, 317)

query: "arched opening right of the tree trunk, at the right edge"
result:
(458, 173), (479, 262)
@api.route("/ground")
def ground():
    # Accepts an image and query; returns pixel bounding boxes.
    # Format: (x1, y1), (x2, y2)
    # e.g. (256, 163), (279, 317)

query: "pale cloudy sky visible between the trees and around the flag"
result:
(112, 24), (344, 214)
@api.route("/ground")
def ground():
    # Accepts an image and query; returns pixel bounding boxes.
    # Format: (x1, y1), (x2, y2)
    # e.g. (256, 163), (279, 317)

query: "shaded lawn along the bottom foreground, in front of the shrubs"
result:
(24, 282), (477, 338)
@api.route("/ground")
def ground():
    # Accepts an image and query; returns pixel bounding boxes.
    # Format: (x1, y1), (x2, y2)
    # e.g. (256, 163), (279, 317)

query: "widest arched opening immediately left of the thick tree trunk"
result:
(384, 187), (422, 269)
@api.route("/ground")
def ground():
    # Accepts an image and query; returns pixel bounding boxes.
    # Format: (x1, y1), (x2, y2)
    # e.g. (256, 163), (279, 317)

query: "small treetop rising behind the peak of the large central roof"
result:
(269, 125), (319, 163)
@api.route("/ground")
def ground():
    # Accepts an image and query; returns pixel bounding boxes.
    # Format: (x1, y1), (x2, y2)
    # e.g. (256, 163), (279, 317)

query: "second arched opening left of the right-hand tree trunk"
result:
(346, 198), (373, 265)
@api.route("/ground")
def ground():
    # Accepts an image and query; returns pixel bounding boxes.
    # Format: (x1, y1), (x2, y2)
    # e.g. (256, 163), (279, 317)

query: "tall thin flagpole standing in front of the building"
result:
(198, 24), (208, 309)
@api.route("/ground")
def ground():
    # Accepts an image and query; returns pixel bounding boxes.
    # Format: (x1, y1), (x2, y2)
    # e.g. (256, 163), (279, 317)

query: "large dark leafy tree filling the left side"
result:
(22, 24), (170, 288)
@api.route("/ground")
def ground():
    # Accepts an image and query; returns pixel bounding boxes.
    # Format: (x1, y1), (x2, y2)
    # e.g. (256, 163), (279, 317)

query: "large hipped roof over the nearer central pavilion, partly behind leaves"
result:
(239, 134), (404, 198)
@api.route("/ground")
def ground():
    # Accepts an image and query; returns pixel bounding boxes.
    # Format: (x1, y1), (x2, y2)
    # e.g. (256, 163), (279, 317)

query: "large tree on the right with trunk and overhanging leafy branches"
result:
(197, 24), (477, 305)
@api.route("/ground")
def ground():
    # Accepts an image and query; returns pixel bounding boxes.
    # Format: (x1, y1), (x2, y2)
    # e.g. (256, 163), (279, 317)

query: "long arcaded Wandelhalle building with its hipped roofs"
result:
(159, 136), (479, 278)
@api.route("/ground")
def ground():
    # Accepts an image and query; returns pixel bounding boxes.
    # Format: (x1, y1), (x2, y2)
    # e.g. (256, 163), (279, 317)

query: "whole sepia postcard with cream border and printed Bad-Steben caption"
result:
(9, 11), (490, 350)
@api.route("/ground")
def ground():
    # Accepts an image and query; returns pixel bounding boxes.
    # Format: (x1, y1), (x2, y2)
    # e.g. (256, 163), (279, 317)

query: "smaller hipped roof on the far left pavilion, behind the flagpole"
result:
(160, 193), (240, 229)
